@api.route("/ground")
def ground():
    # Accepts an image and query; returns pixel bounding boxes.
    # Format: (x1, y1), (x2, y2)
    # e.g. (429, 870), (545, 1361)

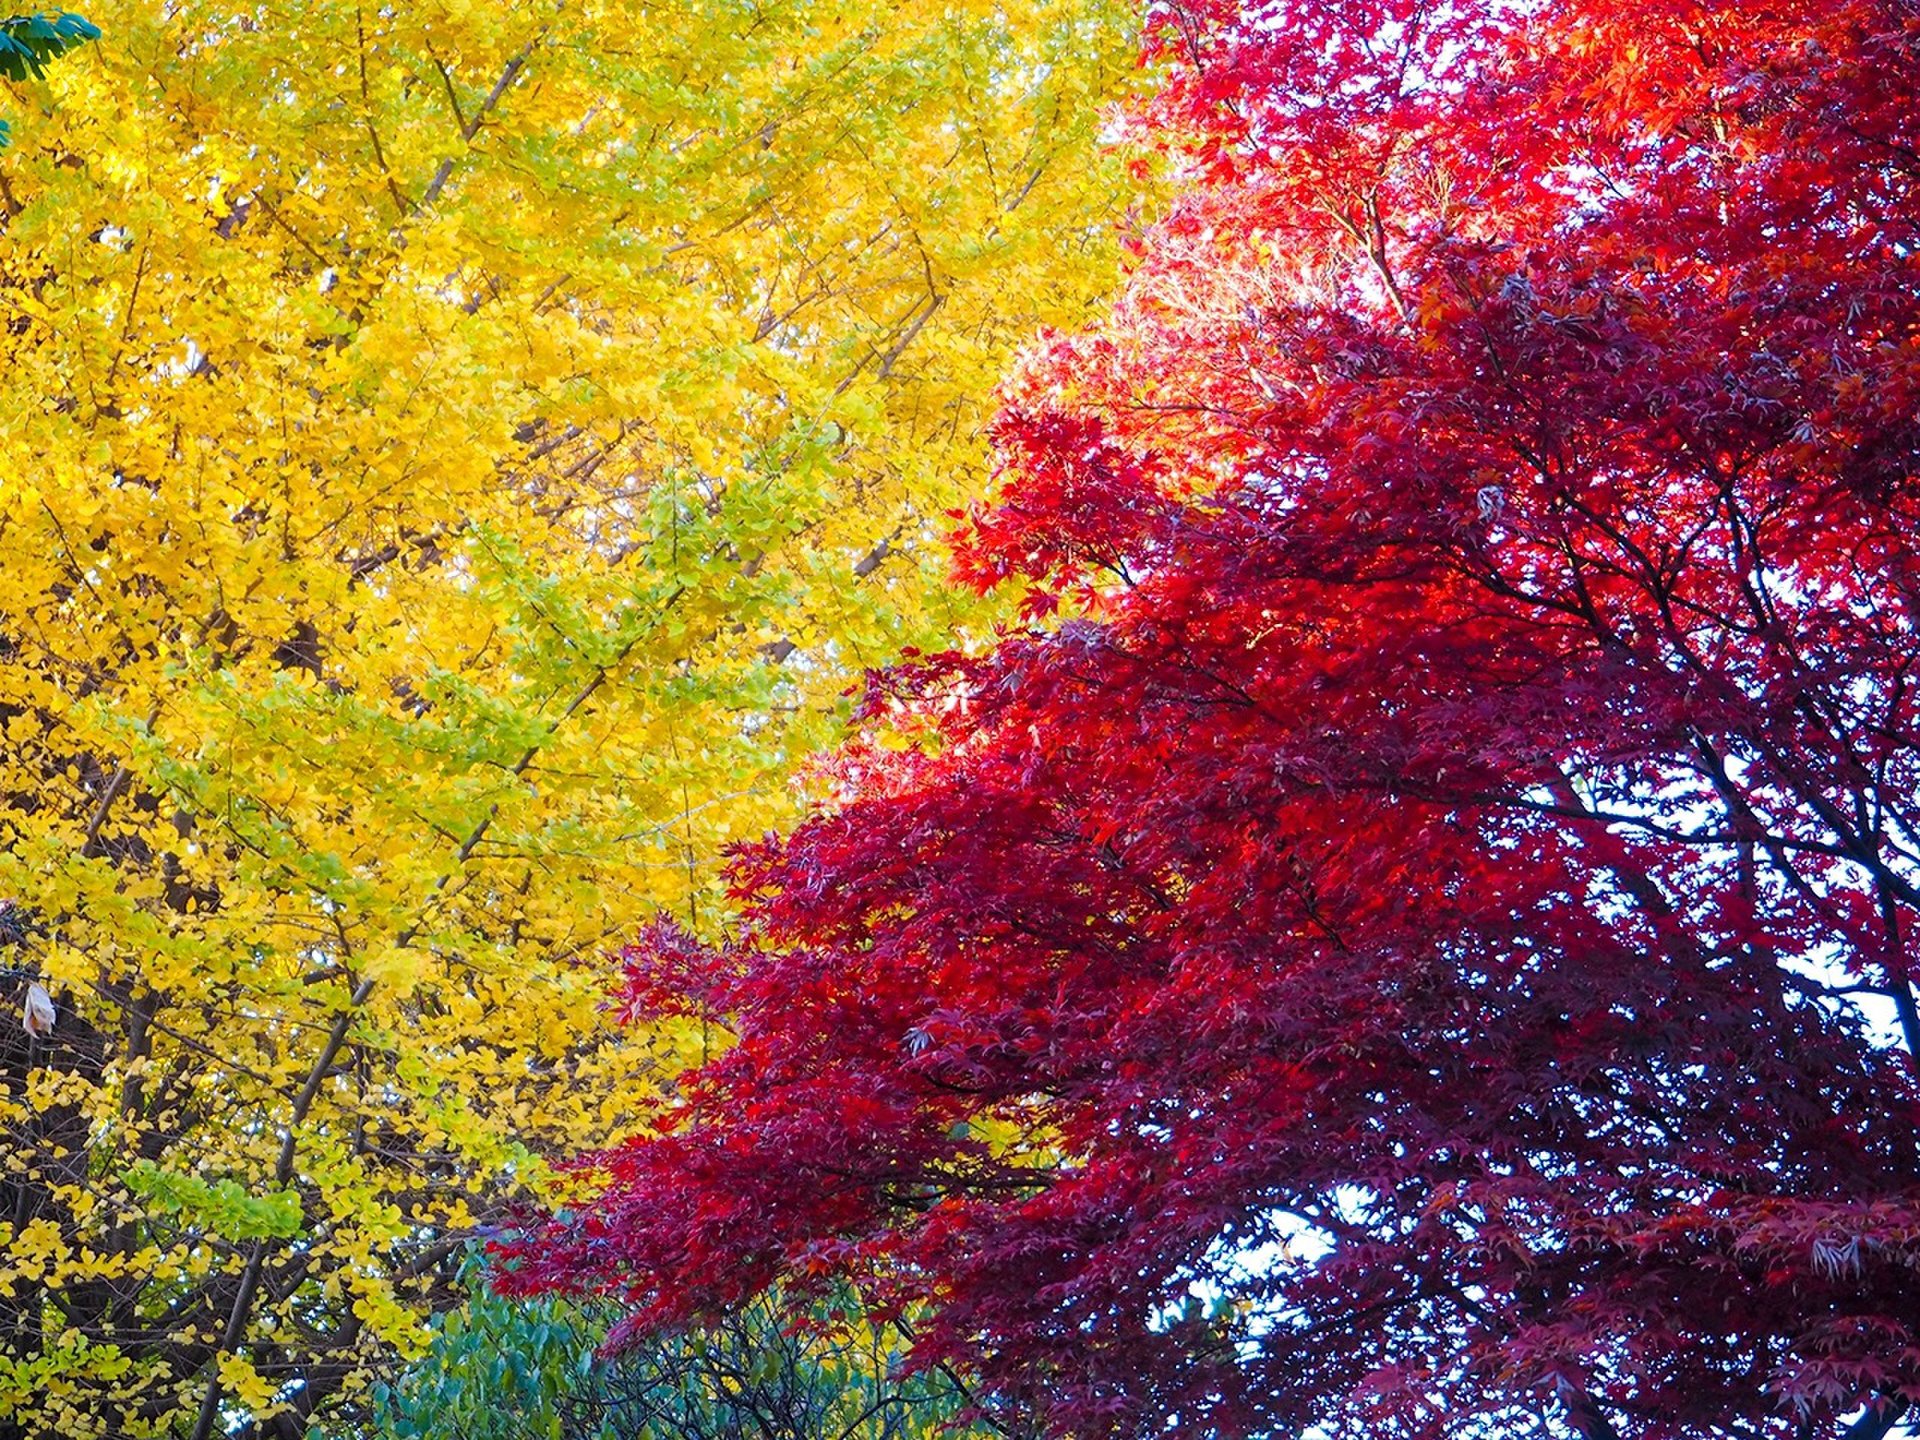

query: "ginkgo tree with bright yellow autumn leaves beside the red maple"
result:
(0, 0), (1133, 1440)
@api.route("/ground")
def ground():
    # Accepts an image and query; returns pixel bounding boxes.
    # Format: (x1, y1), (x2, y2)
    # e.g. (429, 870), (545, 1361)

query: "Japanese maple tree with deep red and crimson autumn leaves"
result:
(503, 0), (1920, 1440)
